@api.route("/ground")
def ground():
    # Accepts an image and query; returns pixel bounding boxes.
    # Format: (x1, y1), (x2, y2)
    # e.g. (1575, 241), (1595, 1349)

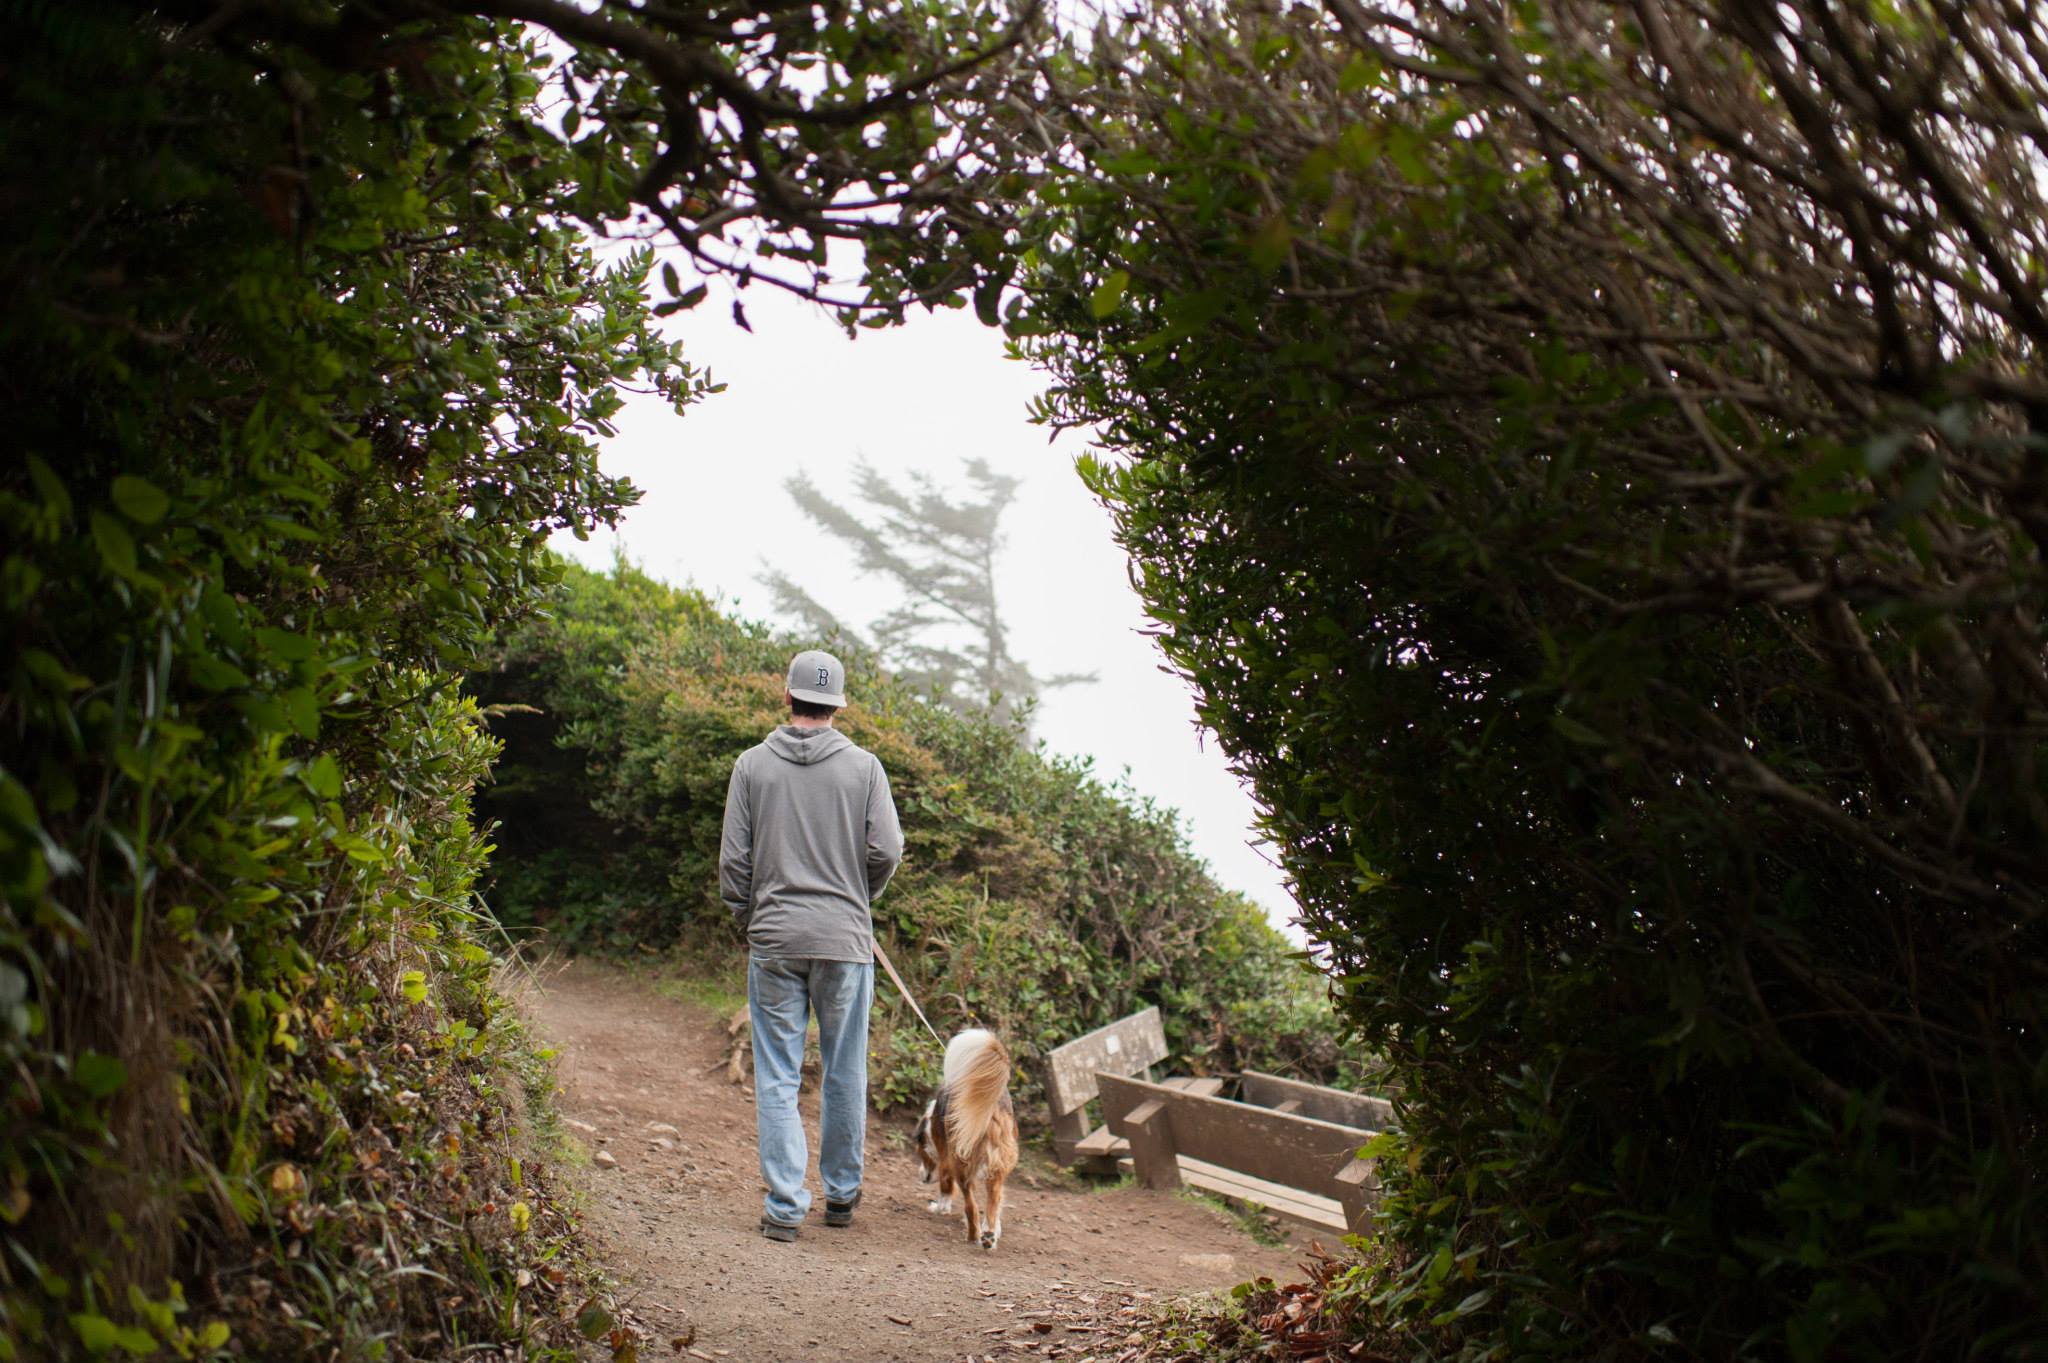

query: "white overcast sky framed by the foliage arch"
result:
(555, 284), (1298, 939)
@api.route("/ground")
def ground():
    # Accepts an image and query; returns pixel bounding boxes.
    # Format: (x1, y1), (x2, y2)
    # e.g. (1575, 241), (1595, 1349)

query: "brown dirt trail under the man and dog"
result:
(522, 962), (1300, 1363)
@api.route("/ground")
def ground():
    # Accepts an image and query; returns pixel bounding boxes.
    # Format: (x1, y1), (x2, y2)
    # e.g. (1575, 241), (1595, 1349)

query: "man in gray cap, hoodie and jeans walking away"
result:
(719, 649), (903, 1240)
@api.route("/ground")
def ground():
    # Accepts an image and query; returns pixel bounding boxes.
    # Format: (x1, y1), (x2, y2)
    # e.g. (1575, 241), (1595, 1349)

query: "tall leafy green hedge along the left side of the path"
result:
(0, 4), (692, 1363)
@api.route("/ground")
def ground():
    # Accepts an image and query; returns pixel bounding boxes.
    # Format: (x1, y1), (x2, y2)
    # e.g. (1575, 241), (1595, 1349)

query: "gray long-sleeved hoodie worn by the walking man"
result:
(719, 724), (903, 962)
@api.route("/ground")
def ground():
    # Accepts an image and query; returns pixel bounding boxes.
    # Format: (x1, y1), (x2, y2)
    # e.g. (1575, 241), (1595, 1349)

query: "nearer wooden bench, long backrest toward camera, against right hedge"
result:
(1096, 1074), (1380, 1234)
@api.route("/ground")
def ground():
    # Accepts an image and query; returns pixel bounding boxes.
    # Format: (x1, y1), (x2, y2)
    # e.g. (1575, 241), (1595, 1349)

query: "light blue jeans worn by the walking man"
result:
(748, 956), (874, 1226)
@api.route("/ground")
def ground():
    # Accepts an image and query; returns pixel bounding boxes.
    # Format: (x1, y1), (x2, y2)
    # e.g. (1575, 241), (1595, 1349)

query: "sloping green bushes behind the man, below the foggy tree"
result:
(473, 565), (1358, 1105)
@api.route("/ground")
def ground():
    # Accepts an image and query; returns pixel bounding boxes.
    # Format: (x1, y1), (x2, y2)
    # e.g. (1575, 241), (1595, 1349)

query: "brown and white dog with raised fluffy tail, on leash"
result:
(913, 1027), (1018, 1250)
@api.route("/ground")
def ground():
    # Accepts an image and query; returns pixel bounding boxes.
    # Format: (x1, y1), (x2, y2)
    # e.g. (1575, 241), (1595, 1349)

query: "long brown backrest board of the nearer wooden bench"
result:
(1100, 1074), (1370, 1201)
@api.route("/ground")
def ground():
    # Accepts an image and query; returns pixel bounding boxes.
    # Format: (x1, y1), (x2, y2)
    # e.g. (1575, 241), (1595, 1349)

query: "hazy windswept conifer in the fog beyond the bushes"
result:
(760, 458), (1096, 724)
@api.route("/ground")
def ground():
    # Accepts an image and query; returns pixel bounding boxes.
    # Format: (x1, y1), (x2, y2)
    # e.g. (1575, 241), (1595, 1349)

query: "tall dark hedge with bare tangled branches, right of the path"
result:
(1014, 0), (2048, 1361)
